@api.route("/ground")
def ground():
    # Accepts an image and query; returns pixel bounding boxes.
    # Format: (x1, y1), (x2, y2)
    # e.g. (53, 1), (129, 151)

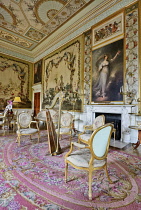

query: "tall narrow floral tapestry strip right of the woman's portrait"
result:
(125, 4), (140, 103)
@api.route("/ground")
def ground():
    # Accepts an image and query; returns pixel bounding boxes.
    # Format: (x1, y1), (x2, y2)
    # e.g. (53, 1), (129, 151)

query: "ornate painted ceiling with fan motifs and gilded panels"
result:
(0, 0), (93, 51)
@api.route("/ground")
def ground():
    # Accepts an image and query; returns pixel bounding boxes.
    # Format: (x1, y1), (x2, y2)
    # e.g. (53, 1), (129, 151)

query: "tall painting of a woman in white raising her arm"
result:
(91, 39), (124, 102)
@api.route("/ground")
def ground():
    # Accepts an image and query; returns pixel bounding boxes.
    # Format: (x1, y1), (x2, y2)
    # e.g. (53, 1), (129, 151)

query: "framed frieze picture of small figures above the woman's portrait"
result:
(92, 13), (124, 48)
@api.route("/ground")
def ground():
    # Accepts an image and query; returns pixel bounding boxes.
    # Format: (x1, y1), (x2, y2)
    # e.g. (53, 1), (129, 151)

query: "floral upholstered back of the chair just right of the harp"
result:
(61, 112), (73, 127)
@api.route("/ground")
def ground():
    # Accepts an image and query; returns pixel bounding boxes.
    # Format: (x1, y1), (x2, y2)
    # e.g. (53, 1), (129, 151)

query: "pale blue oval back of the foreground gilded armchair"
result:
(90, 123), (113, 159)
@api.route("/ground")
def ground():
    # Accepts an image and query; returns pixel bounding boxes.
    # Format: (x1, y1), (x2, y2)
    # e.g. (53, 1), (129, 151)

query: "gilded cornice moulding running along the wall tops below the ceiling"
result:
(0, 0), (137, 62)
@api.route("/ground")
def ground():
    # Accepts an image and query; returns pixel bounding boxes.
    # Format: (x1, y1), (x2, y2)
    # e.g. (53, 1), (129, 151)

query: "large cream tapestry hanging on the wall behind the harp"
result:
(42, 36), (83, 111)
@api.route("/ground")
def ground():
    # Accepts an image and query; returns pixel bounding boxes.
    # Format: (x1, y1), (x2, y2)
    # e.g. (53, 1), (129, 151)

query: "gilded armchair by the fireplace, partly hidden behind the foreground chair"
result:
(78, 115), (105, 144)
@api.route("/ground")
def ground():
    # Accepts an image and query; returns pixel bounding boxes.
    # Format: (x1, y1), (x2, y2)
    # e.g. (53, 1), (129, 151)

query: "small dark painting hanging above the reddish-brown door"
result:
(34, 60), (42, 84)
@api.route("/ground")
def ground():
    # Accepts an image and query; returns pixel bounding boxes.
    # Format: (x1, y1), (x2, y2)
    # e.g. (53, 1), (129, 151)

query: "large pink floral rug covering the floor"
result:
(0, 132), (141, 210)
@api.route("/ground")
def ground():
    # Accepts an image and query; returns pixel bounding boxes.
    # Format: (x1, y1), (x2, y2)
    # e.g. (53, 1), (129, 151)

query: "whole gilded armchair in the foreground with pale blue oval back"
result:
(65, 123), (113, 200)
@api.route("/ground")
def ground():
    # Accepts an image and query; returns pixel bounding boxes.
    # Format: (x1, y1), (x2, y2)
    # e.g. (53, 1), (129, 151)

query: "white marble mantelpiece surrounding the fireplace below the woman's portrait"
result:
(76, 104), (138, 143)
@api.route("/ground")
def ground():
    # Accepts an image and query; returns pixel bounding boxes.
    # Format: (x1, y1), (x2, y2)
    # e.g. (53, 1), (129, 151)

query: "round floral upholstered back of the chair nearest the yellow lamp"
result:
(17, 112), (32, 128)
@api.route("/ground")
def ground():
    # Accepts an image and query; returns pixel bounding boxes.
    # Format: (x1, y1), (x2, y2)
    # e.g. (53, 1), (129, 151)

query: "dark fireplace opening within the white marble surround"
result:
(95, 112), (121, 140)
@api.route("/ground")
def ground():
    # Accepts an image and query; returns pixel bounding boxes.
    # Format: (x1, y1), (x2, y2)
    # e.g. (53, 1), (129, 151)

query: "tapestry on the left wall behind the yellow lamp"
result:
(0, 56), (31, 108)
